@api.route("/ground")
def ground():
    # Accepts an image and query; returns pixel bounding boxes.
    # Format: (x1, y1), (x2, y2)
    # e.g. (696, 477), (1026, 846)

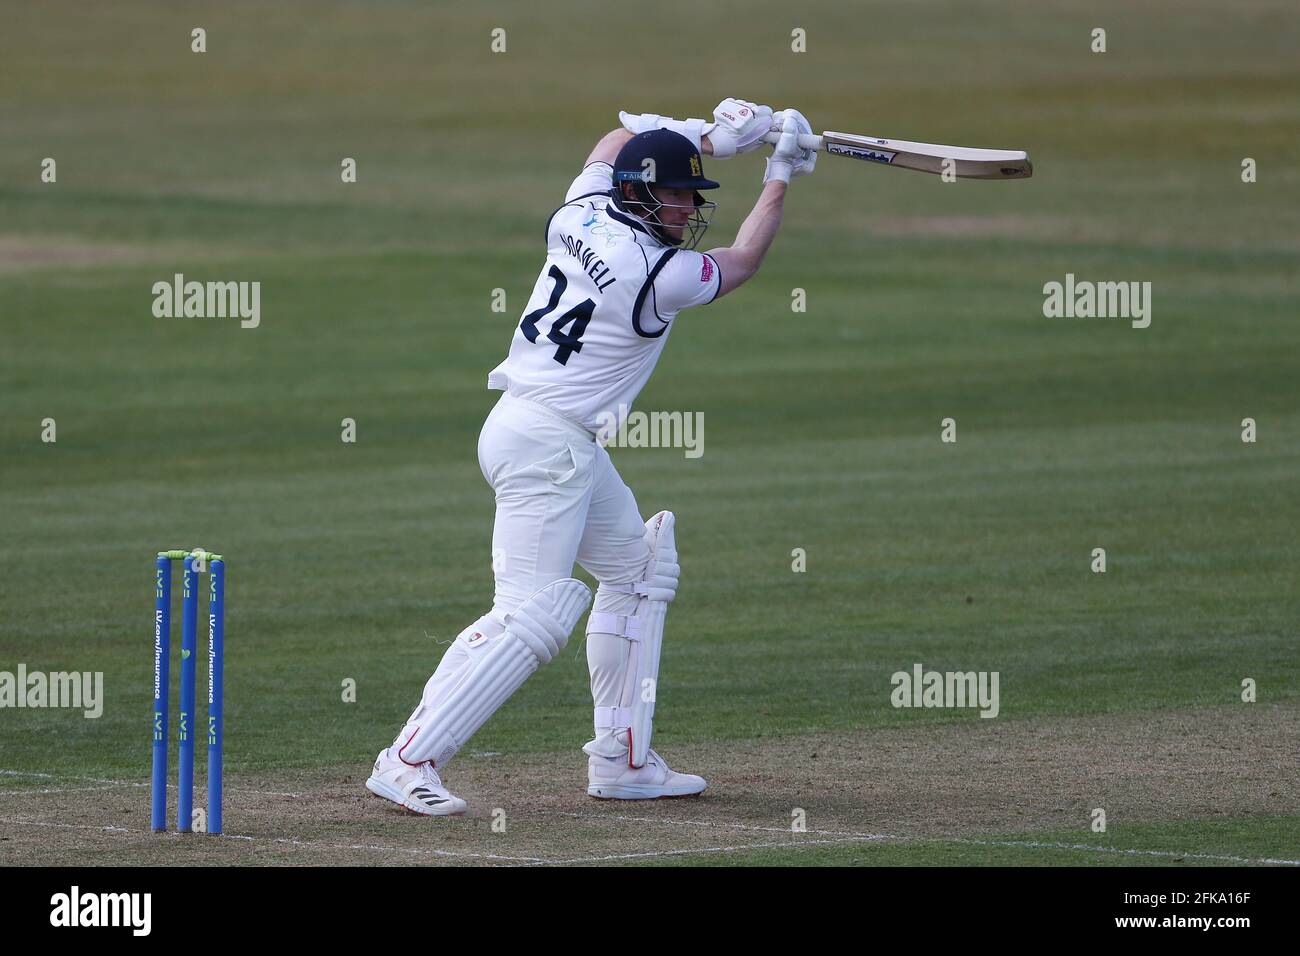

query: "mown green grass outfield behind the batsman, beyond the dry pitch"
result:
(0, 0), (1300, 868)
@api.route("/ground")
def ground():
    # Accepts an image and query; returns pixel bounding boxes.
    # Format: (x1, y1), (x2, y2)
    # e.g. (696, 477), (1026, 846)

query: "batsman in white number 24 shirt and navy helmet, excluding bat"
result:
(365, 98), (816, 816)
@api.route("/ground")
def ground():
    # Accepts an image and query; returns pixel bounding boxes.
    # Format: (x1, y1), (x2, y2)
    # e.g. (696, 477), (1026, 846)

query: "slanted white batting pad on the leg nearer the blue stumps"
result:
(398, 578), (592, 767)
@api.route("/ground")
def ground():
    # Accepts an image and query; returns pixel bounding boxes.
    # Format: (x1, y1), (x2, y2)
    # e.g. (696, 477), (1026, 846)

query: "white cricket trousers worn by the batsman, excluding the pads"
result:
(384, 393), (650, 767)
